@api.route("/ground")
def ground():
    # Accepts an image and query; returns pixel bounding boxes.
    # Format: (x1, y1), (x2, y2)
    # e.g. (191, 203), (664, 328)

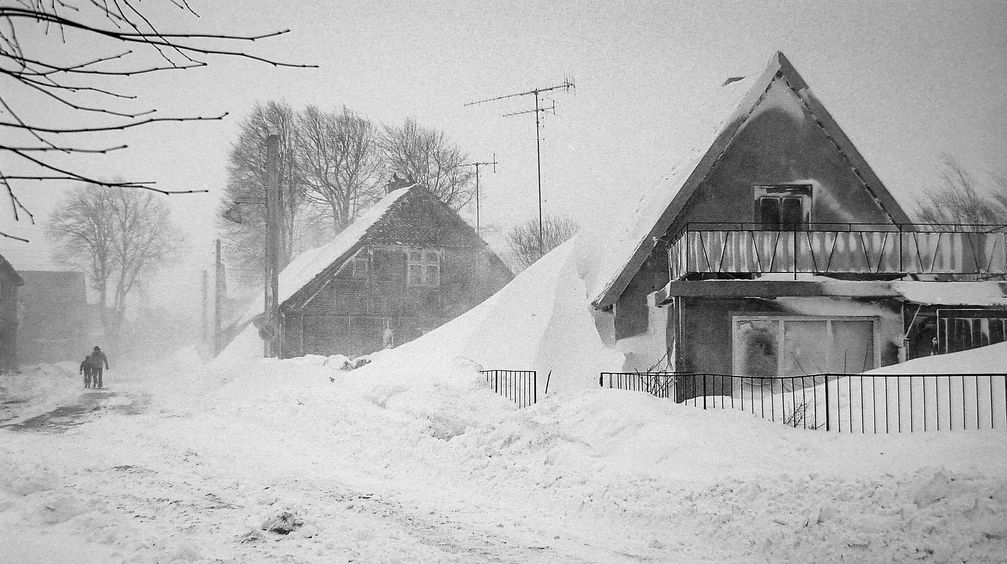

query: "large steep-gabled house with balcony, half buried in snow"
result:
(591, 52), (1007, 376)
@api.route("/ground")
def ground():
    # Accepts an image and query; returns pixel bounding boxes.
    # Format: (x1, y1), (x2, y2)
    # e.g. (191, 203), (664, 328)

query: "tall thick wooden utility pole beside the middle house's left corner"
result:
(261, 135), (283, 359)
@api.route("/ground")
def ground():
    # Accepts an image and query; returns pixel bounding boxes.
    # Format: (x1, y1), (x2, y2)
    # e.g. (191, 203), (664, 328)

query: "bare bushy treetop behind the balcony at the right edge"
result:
(916, 154), (1007, 226)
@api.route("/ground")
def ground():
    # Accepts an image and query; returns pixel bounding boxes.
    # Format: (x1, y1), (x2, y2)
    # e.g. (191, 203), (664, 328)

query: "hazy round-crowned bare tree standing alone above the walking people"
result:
(48, 183), (183, 342)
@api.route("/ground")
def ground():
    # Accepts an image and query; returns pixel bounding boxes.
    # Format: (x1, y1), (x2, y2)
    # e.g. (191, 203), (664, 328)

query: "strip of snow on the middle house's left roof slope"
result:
(239, 184), (418, 324)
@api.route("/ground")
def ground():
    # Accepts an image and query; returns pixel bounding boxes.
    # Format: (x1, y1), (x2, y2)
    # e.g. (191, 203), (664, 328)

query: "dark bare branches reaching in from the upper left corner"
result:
(0, 0), (309, 241)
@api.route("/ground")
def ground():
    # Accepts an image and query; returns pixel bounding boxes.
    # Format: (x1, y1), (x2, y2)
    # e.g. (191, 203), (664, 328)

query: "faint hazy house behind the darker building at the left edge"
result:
(17, 270), (91, 363)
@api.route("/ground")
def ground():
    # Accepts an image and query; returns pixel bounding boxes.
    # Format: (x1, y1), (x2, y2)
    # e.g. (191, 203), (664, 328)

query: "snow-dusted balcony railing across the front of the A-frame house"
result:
(668, 223), (1007, 280)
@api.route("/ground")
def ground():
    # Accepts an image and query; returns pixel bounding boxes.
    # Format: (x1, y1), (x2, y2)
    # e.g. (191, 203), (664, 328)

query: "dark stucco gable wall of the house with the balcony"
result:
(614, 78), (902, 360)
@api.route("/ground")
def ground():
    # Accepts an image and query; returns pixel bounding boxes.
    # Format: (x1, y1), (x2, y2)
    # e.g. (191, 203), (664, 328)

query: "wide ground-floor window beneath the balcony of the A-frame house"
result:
(733, 316), (877, 377)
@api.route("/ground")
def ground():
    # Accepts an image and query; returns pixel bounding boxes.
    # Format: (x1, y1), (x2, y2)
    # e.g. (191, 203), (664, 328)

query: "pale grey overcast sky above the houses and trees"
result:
(0, 0), (1007, 312)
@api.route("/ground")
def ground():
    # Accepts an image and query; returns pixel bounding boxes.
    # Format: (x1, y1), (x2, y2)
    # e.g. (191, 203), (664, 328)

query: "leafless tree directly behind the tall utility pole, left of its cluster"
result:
(219, 101), (305, 280)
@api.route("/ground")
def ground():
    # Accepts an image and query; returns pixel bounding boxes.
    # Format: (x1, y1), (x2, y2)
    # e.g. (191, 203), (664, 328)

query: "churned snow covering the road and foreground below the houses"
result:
(0, 342), (1007, 562)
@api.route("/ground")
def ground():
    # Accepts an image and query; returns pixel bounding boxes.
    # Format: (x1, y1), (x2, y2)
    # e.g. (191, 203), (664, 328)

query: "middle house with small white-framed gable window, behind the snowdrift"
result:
(245, 178), (513, 358)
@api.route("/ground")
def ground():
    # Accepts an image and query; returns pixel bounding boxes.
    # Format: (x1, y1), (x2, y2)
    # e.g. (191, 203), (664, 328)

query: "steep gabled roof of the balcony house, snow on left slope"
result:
(590, 51), (911, 309)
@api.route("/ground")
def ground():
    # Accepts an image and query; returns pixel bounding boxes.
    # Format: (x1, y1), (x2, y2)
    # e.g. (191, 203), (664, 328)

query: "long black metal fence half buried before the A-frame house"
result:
(598, 372), (1007, 433)
